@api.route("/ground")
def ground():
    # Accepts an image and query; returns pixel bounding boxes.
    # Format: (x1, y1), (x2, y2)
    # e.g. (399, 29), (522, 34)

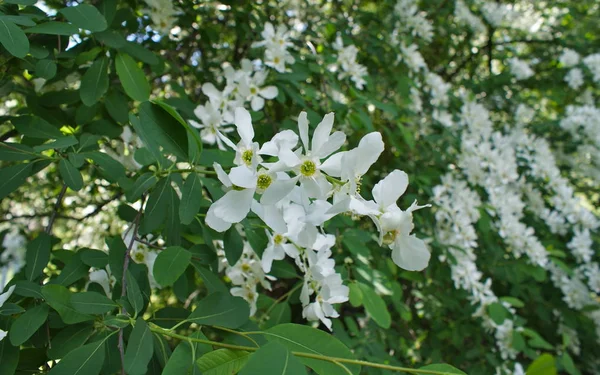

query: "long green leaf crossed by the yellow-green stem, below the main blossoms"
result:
(265, 323), (360, 375)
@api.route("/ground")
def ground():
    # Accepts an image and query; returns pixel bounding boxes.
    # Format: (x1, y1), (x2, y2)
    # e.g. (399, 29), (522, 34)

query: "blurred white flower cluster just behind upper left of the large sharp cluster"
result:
(190, 59), (279, 149)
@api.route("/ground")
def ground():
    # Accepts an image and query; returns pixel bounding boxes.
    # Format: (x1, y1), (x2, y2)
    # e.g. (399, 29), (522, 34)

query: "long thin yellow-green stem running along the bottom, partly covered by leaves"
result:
(149, 323), (452, 375)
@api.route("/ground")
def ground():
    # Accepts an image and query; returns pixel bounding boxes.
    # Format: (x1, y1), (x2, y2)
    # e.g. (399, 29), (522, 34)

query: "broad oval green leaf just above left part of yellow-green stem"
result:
(187, 292), (250, 328)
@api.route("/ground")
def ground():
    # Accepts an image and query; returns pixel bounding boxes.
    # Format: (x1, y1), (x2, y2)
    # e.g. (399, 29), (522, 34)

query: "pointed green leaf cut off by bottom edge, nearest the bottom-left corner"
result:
(48, 340), (105, 375)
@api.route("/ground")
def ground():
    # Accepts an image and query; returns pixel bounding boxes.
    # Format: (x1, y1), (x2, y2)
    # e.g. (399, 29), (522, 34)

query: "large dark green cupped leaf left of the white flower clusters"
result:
(132, 102), (188, 161)
